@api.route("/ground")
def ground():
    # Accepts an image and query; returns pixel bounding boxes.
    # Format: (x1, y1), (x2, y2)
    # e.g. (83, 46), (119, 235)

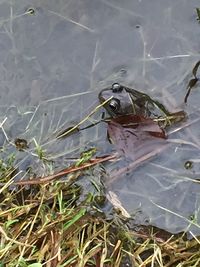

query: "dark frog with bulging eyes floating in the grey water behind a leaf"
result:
(98, 83), (187, 128)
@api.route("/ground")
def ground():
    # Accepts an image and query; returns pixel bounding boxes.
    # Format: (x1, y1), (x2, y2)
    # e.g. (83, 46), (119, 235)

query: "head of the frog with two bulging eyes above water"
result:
(99, 83), (152, 117)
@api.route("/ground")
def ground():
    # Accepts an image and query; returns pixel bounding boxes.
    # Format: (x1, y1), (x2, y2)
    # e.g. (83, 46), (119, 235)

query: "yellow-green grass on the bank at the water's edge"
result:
(0, 157), (200, 267)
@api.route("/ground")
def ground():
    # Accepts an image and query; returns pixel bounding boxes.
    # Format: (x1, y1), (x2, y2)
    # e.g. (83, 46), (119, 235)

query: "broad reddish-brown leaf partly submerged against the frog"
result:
(108, 114), (166, 160)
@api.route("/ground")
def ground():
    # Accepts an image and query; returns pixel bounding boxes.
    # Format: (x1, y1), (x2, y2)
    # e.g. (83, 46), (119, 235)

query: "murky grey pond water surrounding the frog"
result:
(0, 0), (200, 234)
